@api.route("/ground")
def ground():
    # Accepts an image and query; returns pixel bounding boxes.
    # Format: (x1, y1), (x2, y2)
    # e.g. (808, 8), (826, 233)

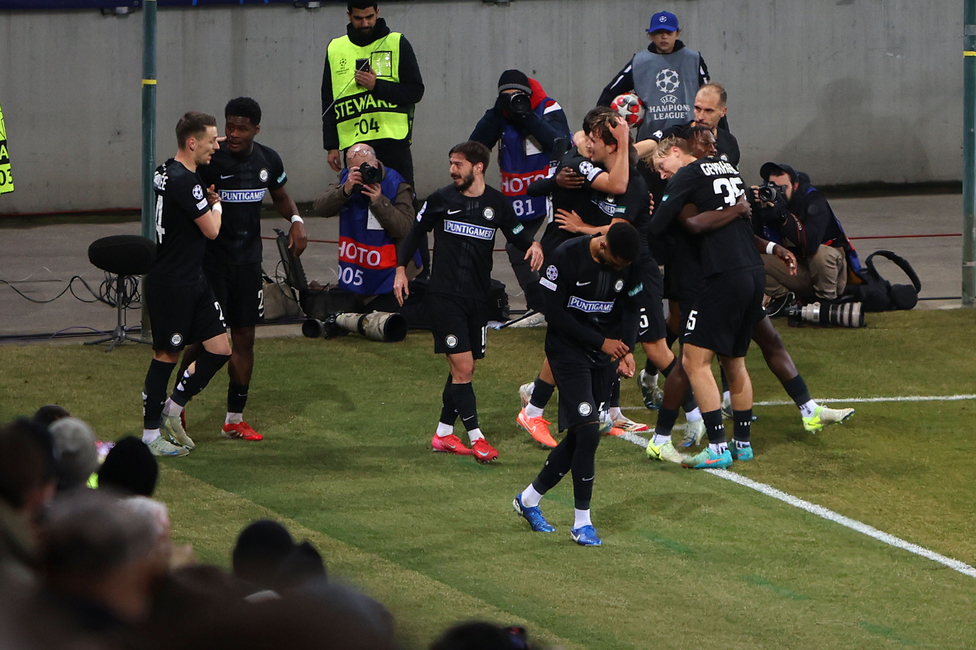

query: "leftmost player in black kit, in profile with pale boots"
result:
(142, 112), (230, 456)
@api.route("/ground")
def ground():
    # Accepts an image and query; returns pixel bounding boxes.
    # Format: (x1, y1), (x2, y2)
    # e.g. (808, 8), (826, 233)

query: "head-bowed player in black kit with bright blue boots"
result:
(512, 222), (643, 546)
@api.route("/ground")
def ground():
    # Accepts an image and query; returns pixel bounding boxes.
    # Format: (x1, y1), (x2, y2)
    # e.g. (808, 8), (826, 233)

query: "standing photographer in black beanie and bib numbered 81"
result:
(469, 70), (572, 327)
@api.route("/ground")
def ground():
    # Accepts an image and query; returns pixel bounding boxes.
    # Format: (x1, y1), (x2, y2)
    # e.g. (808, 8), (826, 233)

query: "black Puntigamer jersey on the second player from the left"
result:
(200, 142), (288, 264)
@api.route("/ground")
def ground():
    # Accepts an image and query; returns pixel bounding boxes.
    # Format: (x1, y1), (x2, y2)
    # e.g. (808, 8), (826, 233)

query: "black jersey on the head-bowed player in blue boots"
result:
(539, 236), (643, 365)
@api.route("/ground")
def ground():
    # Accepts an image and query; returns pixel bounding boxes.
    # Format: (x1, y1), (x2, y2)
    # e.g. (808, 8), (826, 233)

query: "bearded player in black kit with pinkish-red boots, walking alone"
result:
(393, 142), (542, 463)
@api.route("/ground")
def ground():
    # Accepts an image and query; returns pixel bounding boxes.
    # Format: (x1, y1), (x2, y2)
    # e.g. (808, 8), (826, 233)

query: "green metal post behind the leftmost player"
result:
(142, 0), (157, 339)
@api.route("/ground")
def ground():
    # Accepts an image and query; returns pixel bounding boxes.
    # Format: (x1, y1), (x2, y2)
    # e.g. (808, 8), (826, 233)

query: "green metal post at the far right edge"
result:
(962, 0), (976, 307)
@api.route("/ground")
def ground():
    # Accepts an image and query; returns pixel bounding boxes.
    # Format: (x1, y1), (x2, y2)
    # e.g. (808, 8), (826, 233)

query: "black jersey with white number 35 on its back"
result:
(651, 158), (762, 277)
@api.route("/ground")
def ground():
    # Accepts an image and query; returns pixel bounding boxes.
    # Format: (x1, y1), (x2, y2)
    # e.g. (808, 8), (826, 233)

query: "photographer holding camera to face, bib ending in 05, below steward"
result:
(313, 143), (420, 312)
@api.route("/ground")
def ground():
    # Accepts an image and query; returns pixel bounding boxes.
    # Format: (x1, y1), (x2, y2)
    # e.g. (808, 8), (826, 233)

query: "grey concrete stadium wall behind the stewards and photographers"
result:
(0, 0), (963, 214)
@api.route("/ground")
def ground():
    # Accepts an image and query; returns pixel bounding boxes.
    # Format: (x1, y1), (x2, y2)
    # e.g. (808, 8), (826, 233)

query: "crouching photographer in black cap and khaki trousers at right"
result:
(750, 162), (856, 316)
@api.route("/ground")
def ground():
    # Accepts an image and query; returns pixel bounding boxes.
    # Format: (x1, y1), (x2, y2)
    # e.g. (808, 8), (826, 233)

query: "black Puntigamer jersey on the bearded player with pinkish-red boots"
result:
(397, 185), (532, 301)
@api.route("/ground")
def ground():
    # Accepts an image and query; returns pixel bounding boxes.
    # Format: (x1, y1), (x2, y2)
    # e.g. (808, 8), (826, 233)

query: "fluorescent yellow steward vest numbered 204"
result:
(328, 32), (413, 149)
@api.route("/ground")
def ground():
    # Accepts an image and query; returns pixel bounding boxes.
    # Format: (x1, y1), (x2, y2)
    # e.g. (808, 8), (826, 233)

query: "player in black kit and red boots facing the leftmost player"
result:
(181, 97), (308, 441)
